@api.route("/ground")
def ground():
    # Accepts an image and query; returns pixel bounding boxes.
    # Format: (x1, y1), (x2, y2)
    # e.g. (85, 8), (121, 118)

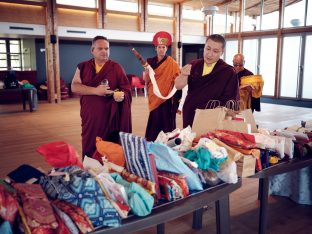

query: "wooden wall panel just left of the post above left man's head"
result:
(57, 8), (97, 28)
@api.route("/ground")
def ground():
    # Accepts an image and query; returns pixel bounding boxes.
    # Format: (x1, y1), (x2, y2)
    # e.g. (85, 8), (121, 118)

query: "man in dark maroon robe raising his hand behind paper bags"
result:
(175, 34), (238, 128)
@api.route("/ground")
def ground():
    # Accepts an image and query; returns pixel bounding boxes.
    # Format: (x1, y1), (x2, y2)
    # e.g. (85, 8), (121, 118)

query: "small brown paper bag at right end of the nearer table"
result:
(236, 155), (256, 177)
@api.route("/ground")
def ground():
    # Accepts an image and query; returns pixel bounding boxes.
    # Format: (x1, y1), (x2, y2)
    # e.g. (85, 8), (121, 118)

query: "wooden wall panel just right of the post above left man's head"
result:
(104, 13), (139, 32)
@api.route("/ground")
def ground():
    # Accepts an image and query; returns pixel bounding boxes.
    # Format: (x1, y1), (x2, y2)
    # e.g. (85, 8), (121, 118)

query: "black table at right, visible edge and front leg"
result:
(249, 156), (312, 234)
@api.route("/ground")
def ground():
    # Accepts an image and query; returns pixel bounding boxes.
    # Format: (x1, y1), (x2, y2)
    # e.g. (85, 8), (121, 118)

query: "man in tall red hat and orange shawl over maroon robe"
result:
(144, 31), (180, 141)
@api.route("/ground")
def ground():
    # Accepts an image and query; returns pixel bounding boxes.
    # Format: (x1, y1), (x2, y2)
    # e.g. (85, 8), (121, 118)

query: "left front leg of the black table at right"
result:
(259, 178), (269, 234)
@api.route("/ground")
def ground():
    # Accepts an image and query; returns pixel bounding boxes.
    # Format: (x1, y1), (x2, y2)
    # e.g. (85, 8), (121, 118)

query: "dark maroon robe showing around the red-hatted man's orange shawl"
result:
(145, 55), (182, 141)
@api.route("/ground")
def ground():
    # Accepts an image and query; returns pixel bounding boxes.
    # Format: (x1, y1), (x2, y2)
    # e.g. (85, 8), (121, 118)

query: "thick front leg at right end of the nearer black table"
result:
(216, 195), (231, 234)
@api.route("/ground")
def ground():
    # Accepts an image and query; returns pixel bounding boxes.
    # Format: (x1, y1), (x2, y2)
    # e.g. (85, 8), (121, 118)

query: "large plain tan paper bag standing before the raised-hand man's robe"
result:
(192, 107), (227, 136)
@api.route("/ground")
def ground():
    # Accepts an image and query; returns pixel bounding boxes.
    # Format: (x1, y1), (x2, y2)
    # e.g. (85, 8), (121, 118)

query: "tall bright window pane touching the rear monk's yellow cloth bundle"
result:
(259, 38), (277, 96)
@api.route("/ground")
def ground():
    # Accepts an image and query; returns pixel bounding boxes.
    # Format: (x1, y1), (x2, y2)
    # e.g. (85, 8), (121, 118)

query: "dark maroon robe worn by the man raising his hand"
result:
(182, 59), (239, 128)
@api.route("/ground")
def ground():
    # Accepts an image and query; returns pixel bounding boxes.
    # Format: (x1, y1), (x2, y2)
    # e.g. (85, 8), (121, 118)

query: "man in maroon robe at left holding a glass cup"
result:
(72, 36), (132, 156)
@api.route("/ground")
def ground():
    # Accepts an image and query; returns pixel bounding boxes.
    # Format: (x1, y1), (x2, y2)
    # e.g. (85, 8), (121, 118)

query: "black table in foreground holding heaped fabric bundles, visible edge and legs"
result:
(94, 180), (242, 234)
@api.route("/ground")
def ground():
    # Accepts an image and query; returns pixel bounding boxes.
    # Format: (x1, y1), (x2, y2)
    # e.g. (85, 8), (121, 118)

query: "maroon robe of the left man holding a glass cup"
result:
(78, 59), (132, 156)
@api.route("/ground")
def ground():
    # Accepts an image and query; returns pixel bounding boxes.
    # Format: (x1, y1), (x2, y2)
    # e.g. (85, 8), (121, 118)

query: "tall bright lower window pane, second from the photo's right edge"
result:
(280, 36), (301, 98)
